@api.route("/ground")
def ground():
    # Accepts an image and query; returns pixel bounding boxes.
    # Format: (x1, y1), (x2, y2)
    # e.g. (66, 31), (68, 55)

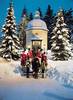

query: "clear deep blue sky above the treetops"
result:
(0, 0), (73, 28)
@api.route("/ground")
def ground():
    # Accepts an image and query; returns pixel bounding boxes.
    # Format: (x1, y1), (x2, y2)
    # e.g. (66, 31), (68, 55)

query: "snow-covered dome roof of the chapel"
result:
(26, 18), (48, 31)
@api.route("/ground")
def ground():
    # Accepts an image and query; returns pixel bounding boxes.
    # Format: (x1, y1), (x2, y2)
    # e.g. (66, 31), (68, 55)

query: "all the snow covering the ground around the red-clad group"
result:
(0, 51), (73, 100)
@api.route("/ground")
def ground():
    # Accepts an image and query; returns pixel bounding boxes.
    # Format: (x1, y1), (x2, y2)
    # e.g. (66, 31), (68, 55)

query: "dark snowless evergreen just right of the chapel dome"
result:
(43, 5), (55, 49)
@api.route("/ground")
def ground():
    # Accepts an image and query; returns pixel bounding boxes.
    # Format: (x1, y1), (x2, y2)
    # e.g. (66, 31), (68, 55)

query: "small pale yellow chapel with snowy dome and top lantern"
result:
(26, 11), (48, 50)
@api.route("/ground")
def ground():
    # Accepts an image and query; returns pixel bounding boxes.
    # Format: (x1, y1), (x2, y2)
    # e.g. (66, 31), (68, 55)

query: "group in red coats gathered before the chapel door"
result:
(21, 49), (47, 78)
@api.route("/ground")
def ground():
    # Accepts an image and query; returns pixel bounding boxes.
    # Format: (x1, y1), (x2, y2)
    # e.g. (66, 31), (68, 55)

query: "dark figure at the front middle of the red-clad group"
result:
(32, 56), (40, 78)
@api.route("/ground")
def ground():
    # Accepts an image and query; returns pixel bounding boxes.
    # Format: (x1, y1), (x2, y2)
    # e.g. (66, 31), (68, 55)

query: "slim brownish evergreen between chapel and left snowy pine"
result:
(18, 8), (29, 49)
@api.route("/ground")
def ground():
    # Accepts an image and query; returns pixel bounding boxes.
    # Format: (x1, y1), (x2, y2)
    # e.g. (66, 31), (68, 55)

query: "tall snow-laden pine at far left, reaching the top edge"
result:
(0, 0), (20, 60)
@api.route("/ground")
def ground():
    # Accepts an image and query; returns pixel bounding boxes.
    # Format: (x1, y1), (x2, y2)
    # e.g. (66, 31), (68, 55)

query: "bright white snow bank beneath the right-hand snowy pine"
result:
(47, 51), (73, 73)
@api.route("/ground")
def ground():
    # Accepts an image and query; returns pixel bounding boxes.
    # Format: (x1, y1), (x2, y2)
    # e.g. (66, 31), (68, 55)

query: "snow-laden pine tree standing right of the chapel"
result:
(51, 10), (71, 60)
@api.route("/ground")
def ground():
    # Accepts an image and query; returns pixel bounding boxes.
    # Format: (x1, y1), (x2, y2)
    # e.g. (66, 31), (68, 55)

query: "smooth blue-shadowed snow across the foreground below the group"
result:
(0, 77), (73, 100)
